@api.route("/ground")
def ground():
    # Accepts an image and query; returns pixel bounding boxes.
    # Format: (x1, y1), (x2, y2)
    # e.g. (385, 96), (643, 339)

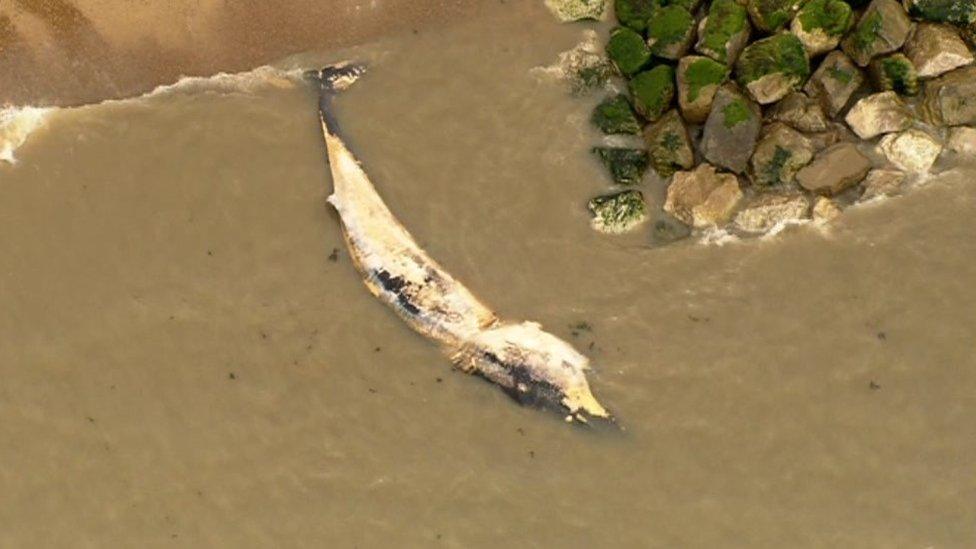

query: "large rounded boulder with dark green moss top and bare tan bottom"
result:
(735, 33), (810, 104)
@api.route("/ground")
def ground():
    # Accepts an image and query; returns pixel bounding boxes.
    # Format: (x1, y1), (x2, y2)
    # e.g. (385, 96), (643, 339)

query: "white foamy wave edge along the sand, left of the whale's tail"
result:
(0, 65), (304, 164)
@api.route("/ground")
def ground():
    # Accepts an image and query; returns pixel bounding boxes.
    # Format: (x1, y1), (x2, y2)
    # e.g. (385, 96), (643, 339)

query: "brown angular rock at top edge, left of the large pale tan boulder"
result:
(842, 0), (912, 67)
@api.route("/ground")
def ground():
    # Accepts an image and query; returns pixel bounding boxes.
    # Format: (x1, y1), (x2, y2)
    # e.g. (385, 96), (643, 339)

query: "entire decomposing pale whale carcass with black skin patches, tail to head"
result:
(310, 64), (612, 421)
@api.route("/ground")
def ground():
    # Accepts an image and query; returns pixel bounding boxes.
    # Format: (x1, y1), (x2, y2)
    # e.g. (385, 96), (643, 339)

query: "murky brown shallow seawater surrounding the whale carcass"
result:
(0, 3), (976, 548)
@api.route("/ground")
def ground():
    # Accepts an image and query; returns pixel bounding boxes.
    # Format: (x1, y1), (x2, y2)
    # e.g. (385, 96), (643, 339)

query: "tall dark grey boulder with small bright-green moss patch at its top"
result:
(701, 86), (762, 173)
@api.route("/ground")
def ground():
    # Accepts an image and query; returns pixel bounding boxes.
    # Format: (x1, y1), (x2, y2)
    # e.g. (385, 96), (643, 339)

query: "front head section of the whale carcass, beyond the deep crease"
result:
(454, 322), (612, 422)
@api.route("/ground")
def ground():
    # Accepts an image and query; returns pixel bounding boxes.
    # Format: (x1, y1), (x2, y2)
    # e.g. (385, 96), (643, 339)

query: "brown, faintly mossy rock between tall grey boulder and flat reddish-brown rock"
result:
(749, 122), (813, 187)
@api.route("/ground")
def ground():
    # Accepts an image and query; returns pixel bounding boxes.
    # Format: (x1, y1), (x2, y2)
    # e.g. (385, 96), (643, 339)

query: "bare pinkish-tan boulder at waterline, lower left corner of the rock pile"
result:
(664, 163), (742, 227)
